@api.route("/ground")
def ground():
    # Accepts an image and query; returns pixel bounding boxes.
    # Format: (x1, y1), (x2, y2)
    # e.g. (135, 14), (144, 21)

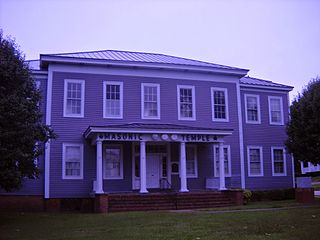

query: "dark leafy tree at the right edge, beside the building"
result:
(286, 77), (320, 168)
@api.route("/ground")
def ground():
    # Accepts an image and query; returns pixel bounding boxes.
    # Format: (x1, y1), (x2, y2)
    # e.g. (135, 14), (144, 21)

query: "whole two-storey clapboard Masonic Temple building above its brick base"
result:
(0, 50), (294, 199)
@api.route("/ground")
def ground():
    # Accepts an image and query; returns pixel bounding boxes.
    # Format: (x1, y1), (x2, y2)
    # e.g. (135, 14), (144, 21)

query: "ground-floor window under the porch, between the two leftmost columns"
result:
(103, 145), (123, 179)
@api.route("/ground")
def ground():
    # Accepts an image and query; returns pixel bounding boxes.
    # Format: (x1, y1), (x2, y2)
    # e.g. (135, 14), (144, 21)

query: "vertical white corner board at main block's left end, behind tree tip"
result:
(44, 65), (53, 199)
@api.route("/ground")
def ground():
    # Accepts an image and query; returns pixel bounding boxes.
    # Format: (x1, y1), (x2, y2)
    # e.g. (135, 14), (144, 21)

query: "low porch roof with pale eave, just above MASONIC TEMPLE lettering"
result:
(83, 123), (233, 139)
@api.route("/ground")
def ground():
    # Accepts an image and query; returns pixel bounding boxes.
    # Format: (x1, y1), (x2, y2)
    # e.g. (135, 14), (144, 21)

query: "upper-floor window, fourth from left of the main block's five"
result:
(177, 85), (196, 120)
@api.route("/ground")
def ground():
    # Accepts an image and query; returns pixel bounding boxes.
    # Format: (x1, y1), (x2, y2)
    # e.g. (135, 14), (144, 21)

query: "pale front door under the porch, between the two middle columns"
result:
(147, 154), (160, 188)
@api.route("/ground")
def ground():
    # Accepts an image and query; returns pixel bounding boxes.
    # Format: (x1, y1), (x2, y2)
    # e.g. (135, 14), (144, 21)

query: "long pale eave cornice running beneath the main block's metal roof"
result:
(40, 54), (249, 77)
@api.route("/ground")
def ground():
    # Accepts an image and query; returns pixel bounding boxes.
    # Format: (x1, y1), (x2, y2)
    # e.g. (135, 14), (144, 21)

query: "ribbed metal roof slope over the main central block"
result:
(42, 50), (247, 70)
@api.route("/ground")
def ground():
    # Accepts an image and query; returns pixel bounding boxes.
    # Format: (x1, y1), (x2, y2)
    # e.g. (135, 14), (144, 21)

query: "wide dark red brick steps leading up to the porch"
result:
(108, 191), (238, 212)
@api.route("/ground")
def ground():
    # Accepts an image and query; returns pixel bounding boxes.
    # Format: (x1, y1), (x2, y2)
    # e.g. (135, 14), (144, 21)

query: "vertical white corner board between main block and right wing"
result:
(237, 83), (246, 189)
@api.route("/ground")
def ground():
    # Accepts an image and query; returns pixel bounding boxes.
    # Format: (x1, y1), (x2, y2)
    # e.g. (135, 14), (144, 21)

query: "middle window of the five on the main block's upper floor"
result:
(141, 83), (160, 119)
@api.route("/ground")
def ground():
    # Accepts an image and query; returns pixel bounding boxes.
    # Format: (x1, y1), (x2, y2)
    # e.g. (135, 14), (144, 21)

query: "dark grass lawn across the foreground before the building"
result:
(0, 201), (320, 240)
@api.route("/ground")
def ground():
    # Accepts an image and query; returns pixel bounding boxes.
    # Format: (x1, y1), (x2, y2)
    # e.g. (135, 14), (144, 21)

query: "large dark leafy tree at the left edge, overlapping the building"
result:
(0, 29), (54, 191)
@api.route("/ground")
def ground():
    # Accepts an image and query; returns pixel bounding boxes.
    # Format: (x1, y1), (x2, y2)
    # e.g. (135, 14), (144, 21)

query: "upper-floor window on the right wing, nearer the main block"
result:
(244, 94), (261, 124)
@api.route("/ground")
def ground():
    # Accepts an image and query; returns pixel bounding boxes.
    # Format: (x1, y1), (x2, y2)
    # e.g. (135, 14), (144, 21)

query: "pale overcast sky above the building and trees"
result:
(0, 0), (320, 100)
